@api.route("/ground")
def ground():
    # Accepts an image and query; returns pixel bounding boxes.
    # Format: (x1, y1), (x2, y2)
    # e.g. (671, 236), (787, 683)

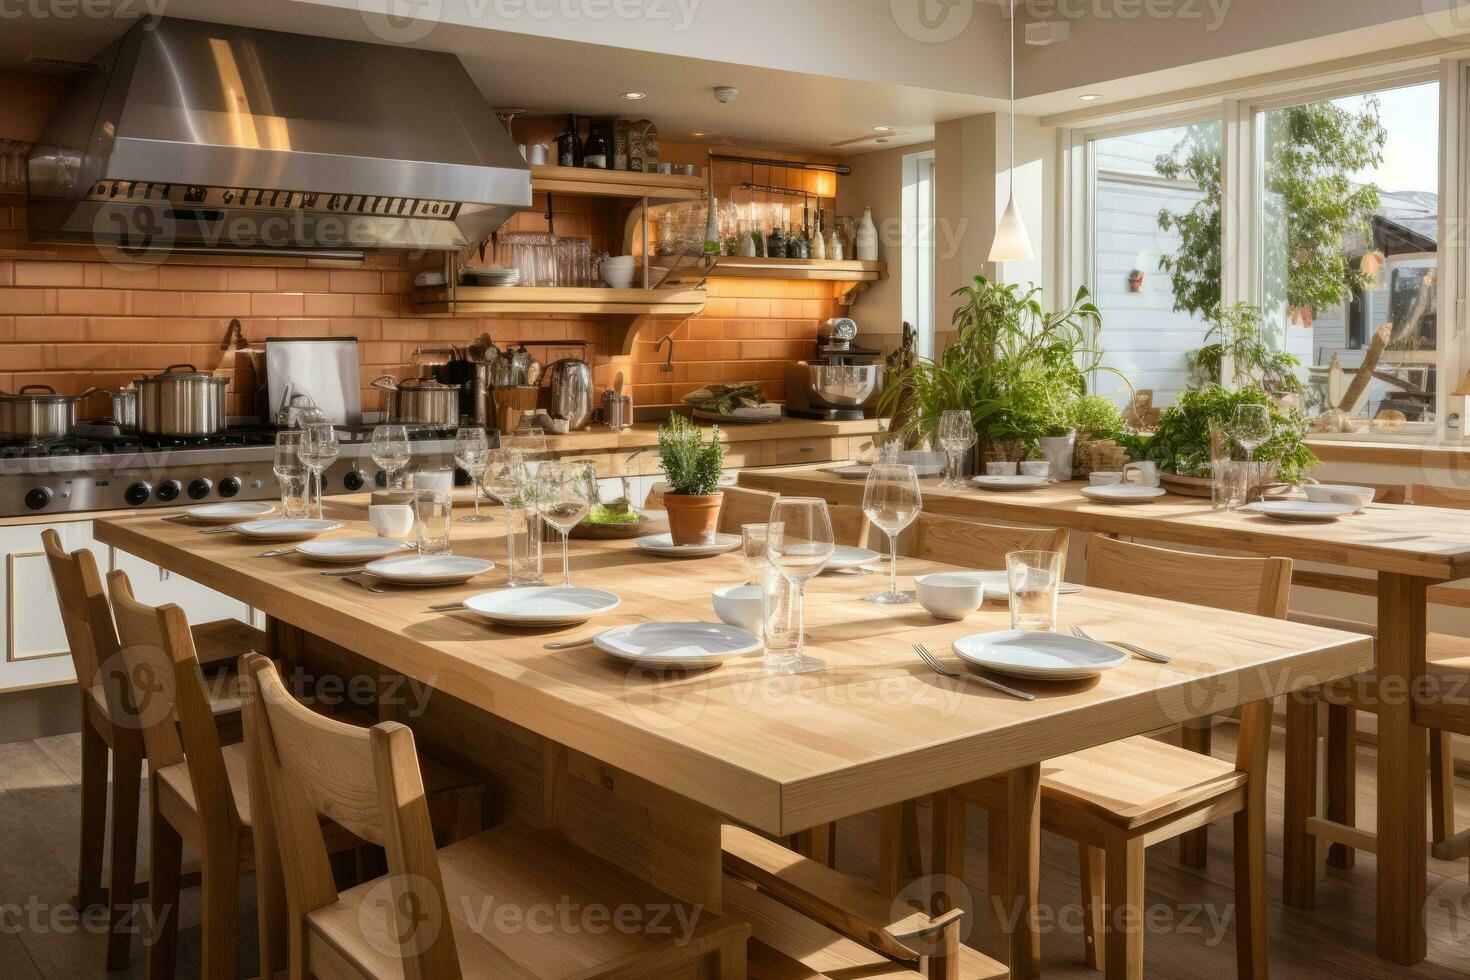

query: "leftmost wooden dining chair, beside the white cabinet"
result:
(41, 529), (268, 970)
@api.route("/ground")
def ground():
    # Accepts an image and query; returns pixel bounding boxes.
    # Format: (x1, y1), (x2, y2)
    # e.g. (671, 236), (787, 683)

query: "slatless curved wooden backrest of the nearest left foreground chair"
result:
(240, 654), (460, 980)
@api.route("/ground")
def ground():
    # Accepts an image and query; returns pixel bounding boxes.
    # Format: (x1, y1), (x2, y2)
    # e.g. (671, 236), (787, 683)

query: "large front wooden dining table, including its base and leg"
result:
(96, 497), (1373, 977)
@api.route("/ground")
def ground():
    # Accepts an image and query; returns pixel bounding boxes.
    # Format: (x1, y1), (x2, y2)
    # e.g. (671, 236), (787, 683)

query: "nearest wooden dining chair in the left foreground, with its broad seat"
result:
(241, 654), (750, 980)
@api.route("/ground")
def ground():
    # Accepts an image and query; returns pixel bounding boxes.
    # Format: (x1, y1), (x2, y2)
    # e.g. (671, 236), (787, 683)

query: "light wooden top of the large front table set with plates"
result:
(96, 498), (1373, 835)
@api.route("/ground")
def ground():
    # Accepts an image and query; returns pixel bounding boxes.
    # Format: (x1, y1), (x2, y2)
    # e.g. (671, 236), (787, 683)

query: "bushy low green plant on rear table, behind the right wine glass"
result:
(1139, 385), (1319, 483)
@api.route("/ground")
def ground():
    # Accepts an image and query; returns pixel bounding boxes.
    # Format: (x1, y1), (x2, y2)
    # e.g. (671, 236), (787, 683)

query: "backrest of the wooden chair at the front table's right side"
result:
(1088, 535), (1291, 619)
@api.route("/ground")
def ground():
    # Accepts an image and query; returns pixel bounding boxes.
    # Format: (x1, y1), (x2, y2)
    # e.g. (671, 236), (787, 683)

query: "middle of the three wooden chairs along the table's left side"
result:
(107, 570), (484, 979)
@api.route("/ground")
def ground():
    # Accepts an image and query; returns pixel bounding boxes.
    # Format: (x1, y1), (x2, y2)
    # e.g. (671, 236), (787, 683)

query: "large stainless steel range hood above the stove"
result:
(29, 18), (531, 254)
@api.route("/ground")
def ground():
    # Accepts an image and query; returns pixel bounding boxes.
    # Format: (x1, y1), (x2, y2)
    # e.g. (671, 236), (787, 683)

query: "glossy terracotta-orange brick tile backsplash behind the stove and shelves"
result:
(0, 195), (842, 417)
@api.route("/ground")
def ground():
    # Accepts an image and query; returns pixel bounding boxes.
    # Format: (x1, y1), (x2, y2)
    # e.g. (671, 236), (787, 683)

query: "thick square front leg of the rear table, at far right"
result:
(1377, 573), (1427, 965)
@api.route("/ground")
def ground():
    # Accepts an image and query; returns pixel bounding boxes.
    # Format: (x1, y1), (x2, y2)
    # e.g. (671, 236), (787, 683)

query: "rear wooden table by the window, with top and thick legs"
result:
(739, 466), (1470, 965)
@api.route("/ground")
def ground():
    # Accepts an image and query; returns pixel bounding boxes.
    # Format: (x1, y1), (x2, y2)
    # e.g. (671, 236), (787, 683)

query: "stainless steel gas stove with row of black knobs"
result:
(0, 423), (463, 519)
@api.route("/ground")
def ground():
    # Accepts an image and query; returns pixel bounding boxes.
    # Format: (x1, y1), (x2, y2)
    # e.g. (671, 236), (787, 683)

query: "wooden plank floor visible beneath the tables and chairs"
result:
(0, 726), (1470, 980)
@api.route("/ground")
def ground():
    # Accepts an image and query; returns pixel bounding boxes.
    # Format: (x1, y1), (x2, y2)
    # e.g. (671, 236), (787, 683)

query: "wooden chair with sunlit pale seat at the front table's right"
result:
(935, 535), (1292, 980)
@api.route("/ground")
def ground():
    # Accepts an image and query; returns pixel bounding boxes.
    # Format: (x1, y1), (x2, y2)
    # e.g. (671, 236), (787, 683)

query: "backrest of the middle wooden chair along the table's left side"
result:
(107, 569), (240, 846)
